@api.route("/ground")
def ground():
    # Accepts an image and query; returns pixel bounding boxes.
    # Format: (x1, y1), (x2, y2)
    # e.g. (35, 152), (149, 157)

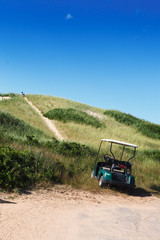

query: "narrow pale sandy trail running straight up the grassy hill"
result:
(24, 97), (64, 141)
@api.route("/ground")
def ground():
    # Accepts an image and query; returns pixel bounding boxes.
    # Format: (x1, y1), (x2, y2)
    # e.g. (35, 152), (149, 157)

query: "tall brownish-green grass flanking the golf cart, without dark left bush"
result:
(1, 138), (160, 193)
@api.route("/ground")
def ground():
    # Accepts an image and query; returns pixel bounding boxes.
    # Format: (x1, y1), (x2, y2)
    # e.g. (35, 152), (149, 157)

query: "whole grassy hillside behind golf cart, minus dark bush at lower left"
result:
(0, 95), (160, 193)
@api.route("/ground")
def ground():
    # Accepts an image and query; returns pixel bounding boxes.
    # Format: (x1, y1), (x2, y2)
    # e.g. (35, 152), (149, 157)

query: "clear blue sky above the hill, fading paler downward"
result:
(0, 0), (160, 124)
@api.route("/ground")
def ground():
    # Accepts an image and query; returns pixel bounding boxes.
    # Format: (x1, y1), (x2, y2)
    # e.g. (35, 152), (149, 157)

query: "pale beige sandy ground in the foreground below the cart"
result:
(0, 187), (160, 240)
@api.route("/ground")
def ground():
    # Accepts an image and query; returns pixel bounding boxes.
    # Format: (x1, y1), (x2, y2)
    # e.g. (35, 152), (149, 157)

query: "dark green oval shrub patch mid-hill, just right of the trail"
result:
(44, 108), (103, 128)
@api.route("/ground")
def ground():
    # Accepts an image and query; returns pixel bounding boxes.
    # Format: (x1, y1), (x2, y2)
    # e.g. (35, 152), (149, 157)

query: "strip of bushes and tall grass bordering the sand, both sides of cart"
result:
(0, 140), (160, 193)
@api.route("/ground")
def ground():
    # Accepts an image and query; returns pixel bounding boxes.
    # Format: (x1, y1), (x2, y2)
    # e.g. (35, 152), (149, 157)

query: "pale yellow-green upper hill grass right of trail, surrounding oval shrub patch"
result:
(27, 95), (160, 150)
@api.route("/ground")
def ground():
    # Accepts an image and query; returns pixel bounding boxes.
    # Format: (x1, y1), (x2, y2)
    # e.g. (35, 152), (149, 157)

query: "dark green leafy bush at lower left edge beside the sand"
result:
(0, 146), (36, 189)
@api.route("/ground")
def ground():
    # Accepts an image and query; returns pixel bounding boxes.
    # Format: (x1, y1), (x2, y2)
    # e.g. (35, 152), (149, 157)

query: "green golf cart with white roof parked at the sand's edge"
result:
(91, 139), (138, 188)
